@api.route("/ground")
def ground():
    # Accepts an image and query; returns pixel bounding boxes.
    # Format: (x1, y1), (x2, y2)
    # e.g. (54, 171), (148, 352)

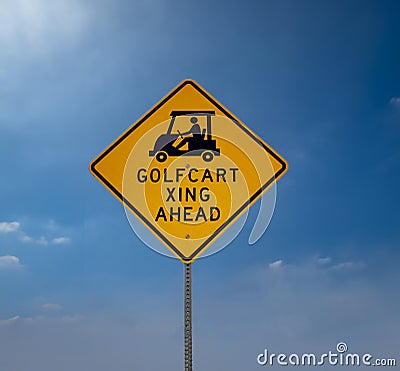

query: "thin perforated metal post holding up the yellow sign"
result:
(184, 264), (193, 371)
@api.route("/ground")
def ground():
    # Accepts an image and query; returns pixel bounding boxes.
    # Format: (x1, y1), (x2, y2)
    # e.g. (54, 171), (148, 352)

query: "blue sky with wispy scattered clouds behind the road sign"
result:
(0, 0), (400, 371)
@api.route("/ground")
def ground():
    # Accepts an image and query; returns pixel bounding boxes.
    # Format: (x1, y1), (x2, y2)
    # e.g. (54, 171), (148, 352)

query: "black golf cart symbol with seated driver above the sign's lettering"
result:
(149, 111), (220, 162)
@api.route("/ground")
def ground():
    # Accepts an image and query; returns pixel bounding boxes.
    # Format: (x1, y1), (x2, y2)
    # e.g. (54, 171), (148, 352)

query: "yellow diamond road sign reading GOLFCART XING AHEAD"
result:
(90, 80), (287, 263)
